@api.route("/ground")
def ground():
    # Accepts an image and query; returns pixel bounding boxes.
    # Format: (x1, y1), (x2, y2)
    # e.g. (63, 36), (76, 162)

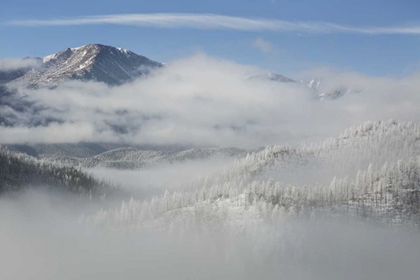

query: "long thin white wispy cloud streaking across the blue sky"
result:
(7, 13), (420, 35)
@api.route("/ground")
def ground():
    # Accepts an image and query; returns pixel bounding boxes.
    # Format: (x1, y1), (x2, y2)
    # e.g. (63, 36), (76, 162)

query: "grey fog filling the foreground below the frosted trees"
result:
(0, 191), (420, 280)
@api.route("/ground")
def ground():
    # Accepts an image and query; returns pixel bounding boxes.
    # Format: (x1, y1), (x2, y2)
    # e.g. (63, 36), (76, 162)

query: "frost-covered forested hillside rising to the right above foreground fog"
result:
(86, 121), (420, 232)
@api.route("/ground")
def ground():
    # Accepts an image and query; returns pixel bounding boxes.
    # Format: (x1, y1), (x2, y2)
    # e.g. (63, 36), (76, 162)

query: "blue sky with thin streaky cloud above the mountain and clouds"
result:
(0, 0), (420, 76)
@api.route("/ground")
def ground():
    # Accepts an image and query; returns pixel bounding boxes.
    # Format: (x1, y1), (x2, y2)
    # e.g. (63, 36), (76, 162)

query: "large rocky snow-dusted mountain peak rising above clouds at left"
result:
(5, 44), (163, 87)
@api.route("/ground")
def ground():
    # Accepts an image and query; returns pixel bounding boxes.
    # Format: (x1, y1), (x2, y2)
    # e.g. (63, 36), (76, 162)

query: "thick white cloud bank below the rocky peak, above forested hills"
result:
(0, 54), (420, 148)
